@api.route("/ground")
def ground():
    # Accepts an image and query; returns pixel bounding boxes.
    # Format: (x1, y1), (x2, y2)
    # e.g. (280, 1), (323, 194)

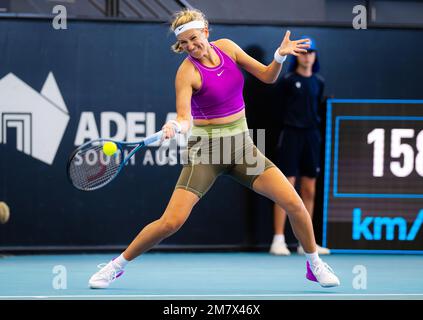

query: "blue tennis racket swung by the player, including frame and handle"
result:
(67, 131), (163, 191)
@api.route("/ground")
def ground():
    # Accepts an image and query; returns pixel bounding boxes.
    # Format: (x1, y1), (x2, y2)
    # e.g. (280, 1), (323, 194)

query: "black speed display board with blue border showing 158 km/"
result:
(323, 99), (423, 254)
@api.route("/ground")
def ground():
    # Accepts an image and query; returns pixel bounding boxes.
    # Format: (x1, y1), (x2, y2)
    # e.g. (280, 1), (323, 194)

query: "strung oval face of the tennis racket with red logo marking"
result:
(69, 144), (122, 190)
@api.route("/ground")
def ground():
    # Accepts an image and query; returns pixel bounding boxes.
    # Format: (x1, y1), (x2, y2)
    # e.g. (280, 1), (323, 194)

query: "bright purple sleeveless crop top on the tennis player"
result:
(188, 44), (245, 119)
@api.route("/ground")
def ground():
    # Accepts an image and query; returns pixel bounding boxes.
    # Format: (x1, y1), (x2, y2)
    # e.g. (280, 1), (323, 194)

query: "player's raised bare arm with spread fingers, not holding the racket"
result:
(229, 31), (310, 83)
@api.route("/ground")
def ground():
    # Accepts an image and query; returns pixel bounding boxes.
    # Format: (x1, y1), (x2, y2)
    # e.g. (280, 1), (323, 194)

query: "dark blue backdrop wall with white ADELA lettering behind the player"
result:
(0, 19), (423, 249)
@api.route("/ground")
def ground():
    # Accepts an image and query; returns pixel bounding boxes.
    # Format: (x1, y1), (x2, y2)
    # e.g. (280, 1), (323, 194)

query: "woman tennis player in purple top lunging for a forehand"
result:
(89, 10), (340, 288)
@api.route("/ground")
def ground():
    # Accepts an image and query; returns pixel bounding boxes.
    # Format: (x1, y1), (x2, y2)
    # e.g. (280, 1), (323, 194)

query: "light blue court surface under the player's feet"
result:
(0, 252), (423, 300)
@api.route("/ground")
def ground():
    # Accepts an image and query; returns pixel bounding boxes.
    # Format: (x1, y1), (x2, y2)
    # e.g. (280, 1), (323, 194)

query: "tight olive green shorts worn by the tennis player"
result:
(175, 117), (275, 198)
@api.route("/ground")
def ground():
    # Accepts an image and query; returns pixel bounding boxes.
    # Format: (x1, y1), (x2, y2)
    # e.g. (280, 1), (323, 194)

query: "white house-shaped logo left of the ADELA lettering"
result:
(0, 72), (69, 165)
